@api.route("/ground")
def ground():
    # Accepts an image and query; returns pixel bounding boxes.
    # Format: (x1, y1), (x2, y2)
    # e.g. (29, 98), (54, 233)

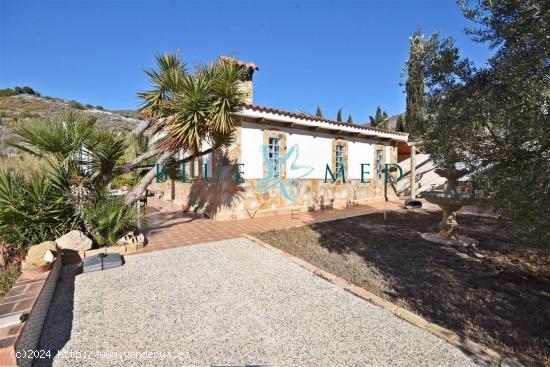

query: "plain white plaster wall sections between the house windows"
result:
(241, 122), (389, 179)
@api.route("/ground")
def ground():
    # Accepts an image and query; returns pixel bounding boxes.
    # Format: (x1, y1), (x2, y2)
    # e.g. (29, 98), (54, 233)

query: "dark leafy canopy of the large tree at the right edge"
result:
(405, 0), (550, 244)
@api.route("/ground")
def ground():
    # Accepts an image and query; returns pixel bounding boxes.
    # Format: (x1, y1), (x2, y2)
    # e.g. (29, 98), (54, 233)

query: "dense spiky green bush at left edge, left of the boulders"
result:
(0, 171), (78, 252)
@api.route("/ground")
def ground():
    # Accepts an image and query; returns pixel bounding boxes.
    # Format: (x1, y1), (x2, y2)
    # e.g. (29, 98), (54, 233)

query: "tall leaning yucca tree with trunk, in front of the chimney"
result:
(126, 54), (247, 203)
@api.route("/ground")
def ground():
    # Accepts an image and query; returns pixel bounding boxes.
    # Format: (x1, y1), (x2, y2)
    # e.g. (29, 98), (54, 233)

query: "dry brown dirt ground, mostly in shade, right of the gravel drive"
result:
(255, 210), (550, 366)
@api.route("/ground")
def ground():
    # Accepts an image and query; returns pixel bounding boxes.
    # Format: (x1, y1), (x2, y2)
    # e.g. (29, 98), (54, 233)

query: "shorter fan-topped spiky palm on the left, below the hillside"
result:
(9, 112), (136, 244)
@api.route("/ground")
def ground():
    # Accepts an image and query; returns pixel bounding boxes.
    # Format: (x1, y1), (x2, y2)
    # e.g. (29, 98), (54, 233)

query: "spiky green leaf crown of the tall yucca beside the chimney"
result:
(146, 54), (246, 153)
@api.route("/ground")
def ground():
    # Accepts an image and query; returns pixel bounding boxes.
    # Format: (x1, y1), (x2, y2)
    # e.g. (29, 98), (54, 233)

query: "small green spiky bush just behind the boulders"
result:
(84, 197), (141, 246)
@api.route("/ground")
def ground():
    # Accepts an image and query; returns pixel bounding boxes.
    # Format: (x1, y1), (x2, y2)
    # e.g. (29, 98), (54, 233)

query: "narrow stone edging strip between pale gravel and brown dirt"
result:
(242, 234), (506, 365)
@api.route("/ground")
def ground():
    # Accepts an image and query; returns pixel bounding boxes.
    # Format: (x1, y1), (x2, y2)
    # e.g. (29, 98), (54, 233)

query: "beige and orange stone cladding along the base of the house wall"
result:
(148, 178), (397, 220)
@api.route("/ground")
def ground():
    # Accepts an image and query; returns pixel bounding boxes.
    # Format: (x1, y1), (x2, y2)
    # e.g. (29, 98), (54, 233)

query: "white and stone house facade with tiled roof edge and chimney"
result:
(149, 58), (408, 220)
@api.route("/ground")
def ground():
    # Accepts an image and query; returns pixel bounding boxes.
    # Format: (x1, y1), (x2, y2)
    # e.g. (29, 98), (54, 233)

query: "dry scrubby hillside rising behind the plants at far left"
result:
(0, 95), (143, 154)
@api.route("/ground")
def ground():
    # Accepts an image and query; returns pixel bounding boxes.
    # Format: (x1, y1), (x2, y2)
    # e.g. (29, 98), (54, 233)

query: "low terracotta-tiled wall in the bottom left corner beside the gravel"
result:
(0, 257), (62, 366)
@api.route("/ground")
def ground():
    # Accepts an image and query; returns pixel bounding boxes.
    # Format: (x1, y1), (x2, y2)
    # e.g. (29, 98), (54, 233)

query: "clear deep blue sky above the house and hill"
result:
(0, 0), (490, 122)
